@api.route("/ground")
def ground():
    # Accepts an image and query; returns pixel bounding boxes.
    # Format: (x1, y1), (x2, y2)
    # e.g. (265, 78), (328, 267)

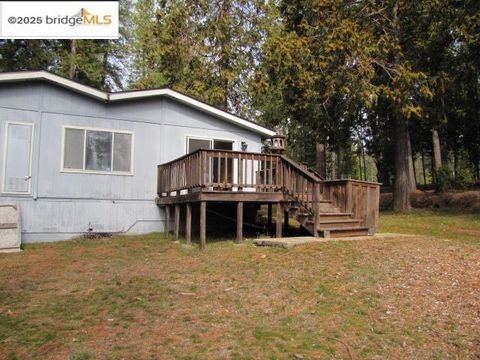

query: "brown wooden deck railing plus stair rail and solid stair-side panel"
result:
(157, 149), (379, 232)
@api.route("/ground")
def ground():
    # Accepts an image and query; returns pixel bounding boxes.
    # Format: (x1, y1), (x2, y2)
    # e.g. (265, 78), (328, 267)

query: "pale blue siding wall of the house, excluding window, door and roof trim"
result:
(0, 82), (261, 242)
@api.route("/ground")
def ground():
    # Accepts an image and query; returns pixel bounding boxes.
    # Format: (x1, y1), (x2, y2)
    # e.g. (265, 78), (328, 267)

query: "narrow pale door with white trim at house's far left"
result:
(3, 123), (33, 194)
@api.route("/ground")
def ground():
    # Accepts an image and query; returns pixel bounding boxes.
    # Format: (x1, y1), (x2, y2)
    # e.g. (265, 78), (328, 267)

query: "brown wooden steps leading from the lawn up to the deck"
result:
(288, 195), (369, 238)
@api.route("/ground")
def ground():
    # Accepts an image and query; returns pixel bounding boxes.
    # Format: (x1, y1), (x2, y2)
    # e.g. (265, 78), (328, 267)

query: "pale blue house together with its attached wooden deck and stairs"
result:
(0, 71), (379, 248)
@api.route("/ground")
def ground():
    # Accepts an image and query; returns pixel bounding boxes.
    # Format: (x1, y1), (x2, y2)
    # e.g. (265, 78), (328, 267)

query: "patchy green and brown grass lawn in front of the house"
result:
(0, 211), (480, 360)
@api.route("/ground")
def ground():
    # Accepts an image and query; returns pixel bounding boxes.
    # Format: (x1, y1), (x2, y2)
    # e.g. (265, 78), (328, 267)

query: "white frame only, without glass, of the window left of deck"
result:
(60, 125), (135, 176)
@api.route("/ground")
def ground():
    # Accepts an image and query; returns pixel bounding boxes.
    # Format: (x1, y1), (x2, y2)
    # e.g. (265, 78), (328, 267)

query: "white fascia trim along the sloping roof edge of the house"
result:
(0, 71), (275, 136)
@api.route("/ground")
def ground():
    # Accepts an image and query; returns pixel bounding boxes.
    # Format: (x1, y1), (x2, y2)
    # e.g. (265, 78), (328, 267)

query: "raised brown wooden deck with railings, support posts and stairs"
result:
(156, 149), (379, 249)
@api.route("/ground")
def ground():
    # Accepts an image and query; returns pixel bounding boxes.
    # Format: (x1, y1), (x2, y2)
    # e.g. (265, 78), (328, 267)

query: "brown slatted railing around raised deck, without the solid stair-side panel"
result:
(157, 149), (321, 211)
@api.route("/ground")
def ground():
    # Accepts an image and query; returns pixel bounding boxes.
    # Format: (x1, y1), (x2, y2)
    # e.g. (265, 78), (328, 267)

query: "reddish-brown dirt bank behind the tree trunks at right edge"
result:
(380, 191), (480, 211)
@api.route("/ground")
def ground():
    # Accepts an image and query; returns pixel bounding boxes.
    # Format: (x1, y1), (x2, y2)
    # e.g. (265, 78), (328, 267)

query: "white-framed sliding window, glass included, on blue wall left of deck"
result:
(62, 126), (134, 175)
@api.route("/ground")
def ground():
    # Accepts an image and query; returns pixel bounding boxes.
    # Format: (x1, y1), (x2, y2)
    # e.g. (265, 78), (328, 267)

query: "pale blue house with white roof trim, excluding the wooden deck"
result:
(0, 71), (274, 242)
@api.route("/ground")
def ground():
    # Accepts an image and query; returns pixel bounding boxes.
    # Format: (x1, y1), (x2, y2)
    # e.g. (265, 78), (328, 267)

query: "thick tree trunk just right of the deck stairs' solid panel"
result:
(393, 116), (412, 211)
